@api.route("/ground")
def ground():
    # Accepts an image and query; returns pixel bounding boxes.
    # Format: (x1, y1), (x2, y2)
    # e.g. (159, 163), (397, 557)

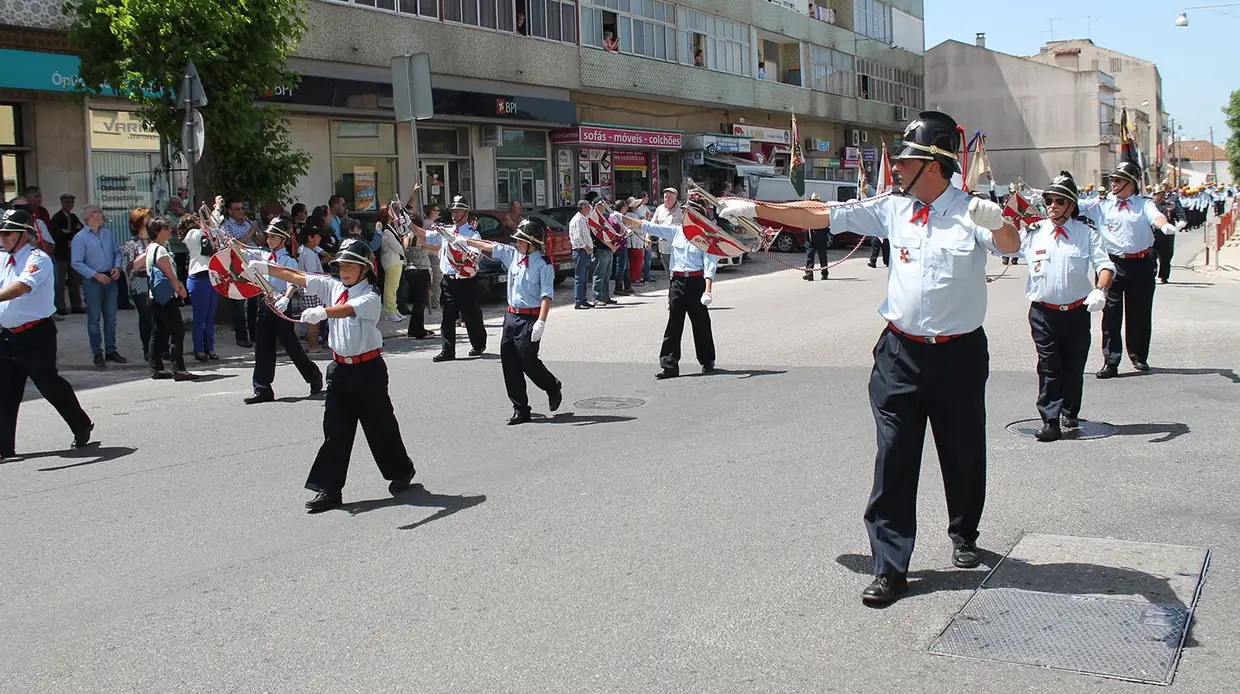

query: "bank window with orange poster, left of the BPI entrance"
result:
(331, 120), (396, 212)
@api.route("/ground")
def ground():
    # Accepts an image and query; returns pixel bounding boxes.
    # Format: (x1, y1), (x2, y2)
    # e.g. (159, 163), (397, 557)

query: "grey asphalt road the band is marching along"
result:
(0, 237), (1240, 693)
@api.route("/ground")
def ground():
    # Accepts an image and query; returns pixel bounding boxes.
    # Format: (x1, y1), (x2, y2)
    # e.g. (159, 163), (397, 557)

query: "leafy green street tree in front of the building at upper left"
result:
(63, 0), (310, 203)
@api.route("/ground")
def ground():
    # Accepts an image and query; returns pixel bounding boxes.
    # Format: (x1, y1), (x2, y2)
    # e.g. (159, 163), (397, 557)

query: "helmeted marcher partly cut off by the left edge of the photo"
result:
(0, 209), (94, 459)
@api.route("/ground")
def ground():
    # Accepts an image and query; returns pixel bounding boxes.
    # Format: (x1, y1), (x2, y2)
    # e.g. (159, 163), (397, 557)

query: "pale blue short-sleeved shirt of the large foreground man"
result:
(831, 186), (998, 337)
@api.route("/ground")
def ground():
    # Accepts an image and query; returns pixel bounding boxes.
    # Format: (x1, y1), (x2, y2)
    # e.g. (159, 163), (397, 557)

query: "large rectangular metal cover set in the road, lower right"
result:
(930, 587), (1190, 684)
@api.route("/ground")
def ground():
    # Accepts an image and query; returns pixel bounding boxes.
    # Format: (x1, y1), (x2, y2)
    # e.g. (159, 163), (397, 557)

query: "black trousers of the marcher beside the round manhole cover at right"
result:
(1029, 304), (1092, 421)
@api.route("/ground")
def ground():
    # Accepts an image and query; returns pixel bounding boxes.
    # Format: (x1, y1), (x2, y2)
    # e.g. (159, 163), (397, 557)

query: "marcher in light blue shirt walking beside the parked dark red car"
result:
(426, 196), (486, 362)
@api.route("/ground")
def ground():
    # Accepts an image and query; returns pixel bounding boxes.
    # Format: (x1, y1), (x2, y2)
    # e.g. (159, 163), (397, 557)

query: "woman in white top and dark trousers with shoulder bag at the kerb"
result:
(144, 217), (198, 380)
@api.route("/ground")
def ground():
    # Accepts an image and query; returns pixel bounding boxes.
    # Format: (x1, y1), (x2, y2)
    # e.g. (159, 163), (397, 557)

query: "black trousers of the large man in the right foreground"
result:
(864, 328), (990, 575)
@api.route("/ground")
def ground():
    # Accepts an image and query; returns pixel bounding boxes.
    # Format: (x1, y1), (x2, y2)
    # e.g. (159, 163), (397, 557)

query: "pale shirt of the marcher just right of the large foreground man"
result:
(1021, 219), (1115, 306)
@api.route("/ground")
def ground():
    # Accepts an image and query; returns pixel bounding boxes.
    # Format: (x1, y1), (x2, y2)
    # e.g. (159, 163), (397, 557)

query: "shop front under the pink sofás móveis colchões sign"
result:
(551, 123), (684, 206)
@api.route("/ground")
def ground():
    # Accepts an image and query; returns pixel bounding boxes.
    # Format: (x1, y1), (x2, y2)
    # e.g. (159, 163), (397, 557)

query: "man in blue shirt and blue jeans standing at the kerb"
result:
(69, 204), (129, 367)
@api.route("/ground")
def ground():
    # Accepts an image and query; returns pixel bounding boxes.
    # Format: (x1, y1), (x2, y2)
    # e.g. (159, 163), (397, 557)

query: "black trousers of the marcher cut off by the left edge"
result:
(0, 318), (91, 455)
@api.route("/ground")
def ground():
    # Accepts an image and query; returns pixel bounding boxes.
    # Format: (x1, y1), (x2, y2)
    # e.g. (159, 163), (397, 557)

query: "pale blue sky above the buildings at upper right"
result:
(925, 0), (1240, 144)
